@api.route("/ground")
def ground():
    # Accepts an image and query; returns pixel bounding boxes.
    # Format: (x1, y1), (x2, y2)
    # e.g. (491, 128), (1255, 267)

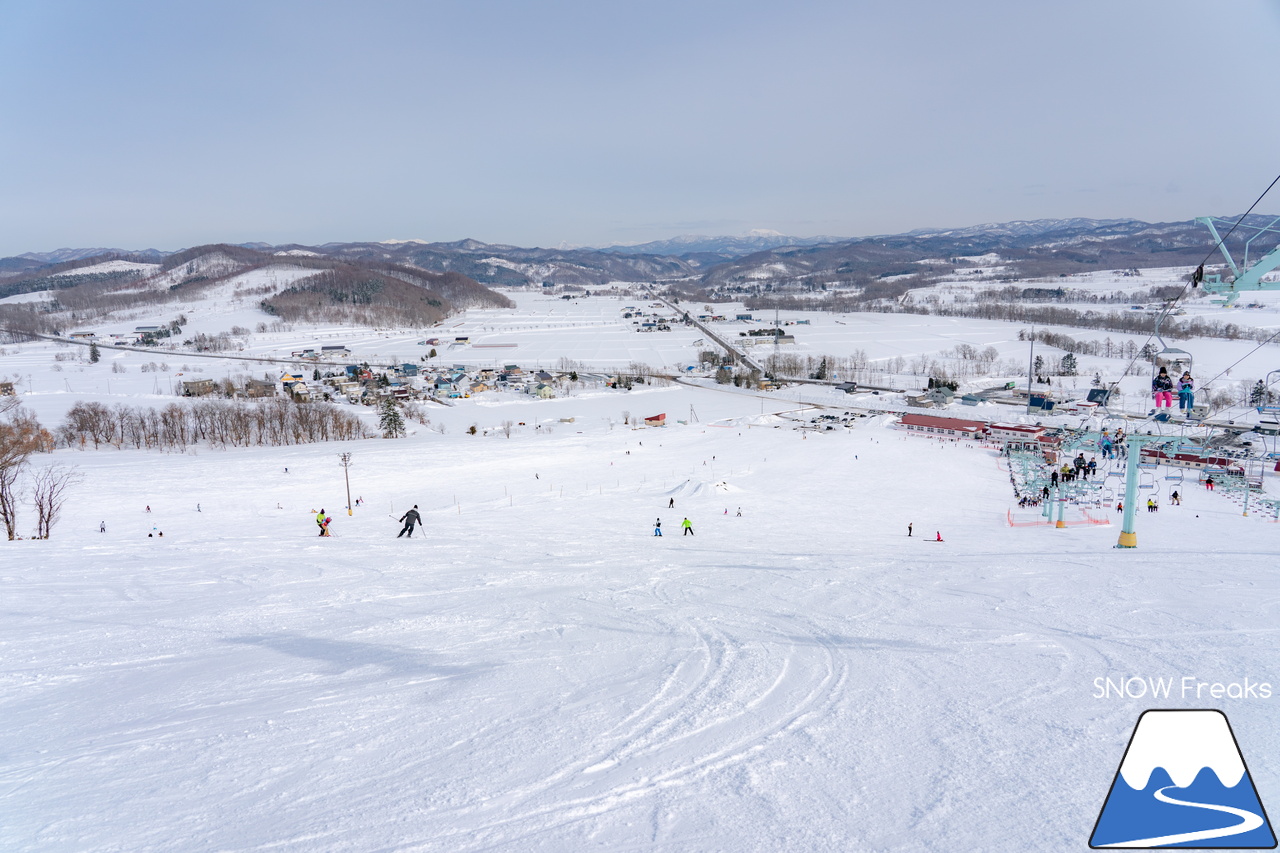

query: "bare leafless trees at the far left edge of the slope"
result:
(0, 397), (71, 540)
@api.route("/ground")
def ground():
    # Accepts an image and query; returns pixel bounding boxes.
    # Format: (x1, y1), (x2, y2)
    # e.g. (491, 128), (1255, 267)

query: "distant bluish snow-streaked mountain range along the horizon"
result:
(0, 215), (1275, 289)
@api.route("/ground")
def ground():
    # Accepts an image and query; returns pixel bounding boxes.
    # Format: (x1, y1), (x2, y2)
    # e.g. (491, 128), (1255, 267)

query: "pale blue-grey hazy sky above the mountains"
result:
(0, 0), (1280, 256)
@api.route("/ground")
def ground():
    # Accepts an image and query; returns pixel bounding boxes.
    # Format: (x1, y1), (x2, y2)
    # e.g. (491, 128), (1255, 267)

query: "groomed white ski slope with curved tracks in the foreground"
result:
(0, 402), (1280, 852)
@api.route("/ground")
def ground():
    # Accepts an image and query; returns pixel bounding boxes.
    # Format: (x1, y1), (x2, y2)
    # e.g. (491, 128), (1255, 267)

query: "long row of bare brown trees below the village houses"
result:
(58, 398), (370, 451)
